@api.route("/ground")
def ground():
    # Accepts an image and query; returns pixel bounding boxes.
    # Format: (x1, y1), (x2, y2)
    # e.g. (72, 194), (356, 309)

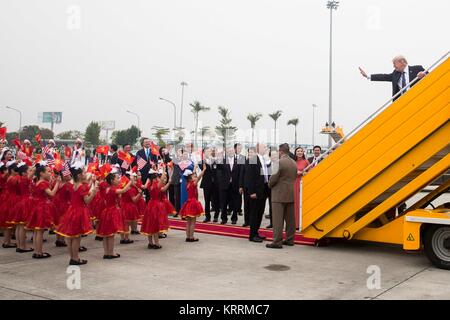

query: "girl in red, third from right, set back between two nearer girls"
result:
(120, 171), (142, 244)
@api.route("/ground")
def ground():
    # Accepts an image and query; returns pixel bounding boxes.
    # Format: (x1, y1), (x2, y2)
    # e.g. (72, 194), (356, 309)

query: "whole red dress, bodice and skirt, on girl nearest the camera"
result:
(56, 184), (93, 238)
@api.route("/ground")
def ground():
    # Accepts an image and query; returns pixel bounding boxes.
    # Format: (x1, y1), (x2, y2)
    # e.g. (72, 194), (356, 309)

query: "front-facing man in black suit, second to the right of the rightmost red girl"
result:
(217, 147), (241, 224)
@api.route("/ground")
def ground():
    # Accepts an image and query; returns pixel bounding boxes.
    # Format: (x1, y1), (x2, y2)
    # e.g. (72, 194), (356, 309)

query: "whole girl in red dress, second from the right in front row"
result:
(141, 169), (173, 249)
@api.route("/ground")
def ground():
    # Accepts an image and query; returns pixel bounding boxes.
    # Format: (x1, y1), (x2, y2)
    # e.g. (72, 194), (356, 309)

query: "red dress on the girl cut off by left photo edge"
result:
(0, 176), (20, 229)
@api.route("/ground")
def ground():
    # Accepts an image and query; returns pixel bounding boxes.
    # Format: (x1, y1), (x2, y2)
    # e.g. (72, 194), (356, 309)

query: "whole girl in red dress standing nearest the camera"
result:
(56, 164), (98, 265)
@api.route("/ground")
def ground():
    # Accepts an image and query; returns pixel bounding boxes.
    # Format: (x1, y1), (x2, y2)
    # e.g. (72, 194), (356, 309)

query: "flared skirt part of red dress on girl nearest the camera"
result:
(55, 206), (93, 238)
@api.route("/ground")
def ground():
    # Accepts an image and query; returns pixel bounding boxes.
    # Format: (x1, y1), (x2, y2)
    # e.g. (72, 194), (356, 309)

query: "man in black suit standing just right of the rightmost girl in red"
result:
(198, 148), (219, 222)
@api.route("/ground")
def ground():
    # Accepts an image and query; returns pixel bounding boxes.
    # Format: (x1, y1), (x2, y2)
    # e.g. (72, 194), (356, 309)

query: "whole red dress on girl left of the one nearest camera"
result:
(25, 180), (56, 230)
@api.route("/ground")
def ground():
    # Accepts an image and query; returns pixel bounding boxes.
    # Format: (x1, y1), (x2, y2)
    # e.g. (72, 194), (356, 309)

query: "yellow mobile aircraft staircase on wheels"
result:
(300, 52), (450, 269)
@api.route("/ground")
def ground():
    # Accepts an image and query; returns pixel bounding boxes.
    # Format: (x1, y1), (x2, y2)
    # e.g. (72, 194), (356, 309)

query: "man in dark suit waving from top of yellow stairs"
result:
(359, 56), (426, 100)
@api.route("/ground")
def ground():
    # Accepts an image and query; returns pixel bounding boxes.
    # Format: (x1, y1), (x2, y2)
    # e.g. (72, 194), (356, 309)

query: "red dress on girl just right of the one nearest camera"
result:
(97, 186), (125, 237)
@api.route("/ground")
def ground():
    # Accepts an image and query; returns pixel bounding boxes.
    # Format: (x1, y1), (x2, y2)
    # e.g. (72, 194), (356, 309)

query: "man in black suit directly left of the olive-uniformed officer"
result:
(244, 144), (269, 242)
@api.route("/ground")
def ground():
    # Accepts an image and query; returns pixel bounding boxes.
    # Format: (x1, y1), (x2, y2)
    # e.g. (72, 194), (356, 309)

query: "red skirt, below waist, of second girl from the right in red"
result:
(141, 200), (169, 236)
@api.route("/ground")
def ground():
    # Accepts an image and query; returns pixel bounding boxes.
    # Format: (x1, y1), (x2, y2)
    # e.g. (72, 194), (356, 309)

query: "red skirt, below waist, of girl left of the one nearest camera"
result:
(25, 200), (56, 230)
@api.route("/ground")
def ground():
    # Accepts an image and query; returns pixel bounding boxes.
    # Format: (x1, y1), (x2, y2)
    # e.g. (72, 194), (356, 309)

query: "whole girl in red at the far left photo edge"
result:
(0, 160), (20, 249)
